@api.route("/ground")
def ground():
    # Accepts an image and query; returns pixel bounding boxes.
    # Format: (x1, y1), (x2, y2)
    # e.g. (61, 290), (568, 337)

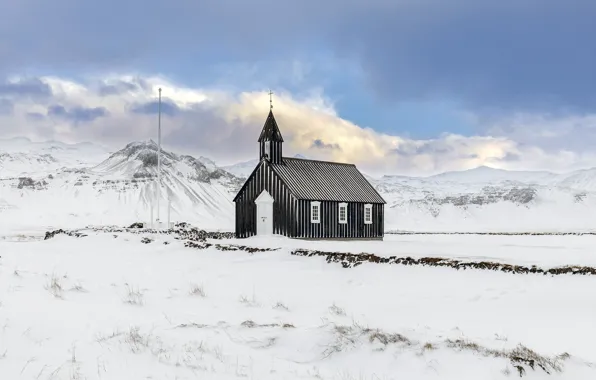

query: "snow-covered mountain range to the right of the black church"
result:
(371, 167), (596, 231)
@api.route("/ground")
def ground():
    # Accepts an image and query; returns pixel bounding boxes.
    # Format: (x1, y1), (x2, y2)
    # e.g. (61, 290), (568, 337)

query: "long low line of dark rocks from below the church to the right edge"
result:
(292, 249), (596, 276)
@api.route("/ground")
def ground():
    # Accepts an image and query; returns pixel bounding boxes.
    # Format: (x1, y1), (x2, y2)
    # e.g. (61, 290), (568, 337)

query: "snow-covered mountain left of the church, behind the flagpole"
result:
(0, 141), (243, 229)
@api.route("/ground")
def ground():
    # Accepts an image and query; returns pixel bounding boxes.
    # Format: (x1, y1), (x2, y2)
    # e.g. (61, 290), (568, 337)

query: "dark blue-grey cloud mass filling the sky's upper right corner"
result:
(336, 0), (596, 112)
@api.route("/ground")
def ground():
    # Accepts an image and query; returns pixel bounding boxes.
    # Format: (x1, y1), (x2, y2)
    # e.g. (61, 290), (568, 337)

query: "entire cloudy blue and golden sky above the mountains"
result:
(0, 0), (596, 175)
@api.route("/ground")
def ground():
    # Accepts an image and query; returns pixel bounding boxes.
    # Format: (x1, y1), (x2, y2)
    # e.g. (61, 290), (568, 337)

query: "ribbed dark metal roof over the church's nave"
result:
(271, 157), (386, 203)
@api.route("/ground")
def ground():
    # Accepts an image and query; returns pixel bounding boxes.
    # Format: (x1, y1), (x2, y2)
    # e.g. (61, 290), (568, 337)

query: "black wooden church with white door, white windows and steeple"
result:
(234, 110), (386, 240)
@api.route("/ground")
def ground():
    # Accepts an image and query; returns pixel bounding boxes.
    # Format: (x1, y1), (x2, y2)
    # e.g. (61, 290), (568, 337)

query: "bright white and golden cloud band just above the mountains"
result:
(0, 75), (596, 175)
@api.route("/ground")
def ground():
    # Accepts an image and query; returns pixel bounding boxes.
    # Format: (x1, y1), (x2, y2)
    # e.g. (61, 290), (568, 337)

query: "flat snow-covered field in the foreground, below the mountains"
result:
(0, 227), (596, 380)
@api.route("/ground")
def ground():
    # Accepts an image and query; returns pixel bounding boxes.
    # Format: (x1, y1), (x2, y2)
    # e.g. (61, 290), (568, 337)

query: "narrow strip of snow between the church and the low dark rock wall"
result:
(228, 235), (596, 267)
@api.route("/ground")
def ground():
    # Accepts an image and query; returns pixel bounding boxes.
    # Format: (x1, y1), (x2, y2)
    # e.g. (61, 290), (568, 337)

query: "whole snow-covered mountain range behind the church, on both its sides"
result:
(0, 139), (596, 231)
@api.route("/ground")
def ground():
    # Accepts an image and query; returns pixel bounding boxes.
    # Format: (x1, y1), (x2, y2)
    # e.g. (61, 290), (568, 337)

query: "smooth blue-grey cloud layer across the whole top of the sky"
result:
(0, 0), (596, 113)
